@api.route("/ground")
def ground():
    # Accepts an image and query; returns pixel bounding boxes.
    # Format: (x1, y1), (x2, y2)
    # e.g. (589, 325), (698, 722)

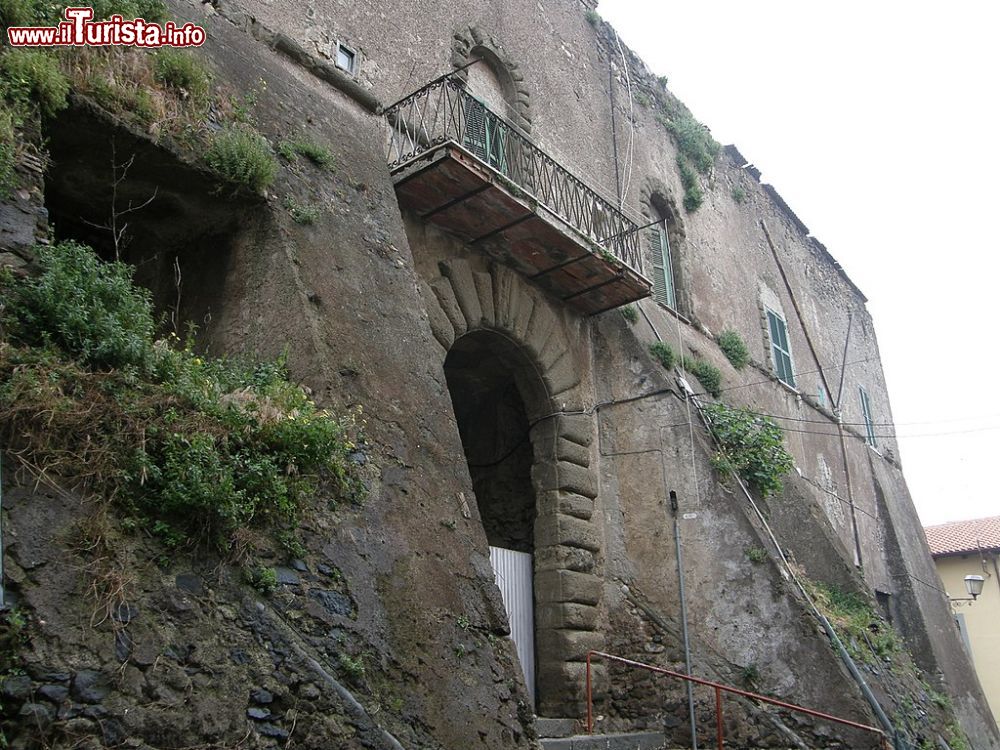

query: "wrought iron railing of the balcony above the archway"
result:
(385, 75), (642, 275)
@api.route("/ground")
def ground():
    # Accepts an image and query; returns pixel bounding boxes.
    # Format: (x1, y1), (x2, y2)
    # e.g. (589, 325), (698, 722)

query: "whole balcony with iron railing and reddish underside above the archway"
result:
(385, 75), (652, 315)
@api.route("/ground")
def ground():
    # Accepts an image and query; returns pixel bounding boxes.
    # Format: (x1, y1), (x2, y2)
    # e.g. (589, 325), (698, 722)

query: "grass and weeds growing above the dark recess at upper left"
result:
(0, 0), (282, 197)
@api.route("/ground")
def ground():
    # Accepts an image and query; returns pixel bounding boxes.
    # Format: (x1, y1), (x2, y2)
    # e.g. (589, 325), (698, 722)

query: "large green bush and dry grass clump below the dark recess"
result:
(0, 243), (363, 549)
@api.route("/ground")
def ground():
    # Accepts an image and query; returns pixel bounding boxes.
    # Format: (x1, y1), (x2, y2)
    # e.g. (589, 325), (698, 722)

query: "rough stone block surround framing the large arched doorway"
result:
(421, 258), (605, 716)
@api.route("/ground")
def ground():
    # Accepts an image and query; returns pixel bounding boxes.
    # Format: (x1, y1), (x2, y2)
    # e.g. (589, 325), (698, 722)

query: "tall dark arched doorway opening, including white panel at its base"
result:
(444, 329), (547, 701)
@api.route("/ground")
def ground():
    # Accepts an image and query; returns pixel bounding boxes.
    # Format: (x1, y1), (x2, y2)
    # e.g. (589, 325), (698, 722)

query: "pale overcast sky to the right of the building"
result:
(598, 0), (1000, 524)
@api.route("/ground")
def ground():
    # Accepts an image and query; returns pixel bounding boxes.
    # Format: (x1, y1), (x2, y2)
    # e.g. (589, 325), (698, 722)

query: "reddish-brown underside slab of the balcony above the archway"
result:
(393, 142), (652, 315)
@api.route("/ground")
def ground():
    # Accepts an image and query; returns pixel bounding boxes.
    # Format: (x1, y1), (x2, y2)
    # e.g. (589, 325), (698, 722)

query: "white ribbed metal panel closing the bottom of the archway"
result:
(490, 547), (535, 706)
